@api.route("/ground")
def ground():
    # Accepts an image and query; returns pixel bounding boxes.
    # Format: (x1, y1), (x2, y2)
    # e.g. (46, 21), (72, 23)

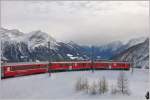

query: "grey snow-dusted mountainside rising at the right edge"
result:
(112, 38), (149, 68)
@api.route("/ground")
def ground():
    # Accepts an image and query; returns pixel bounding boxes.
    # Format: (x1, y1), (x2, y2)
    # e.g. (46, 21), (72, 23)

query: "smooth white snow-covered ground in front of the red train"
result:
(0, 69), (149, 100)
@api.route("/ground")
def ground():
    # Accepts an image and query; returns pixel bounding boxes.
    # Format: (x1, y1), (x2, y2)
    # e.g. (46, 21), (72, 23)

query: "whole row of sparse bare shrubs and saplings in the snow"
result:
(75, 72), (130, 95)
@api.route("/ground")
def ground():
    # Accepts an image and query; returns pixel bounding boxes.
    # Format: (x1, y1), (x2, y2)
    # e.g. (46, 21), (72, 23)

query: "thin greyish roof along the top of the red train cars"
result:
(2, 60), (130, 66)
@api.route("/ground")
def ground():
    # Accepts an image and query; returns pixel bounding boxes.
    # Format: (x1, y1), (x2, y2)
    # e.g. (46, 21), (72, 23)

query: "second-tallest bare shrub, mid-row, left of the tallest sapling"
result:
(98, 77), (108, 94)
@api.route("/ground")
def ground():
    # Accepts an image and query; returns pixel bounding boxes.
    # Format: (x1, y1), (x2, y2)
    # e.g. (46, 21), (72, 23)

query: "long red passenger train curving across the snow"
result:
(1, 61), (130, 78)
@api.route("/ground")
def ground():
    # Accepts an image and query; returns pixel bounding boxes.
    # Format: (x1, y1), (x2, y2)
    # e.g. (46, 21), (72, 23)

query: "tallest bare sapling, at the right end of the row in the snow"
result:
(117, 72), (129, 94)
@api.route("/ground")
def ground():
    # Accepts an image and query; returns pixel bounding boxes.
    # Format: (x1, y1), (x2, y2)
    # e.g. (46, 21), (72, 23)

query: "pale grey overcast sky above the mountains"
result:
(1, 1), (149, 45)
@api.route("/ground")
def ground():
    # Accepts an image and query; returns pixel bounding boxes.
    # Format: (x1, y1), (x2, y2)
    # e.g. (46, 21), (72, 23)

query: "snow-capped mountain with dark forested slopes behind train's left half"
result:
(0, 28), (88, 62)
